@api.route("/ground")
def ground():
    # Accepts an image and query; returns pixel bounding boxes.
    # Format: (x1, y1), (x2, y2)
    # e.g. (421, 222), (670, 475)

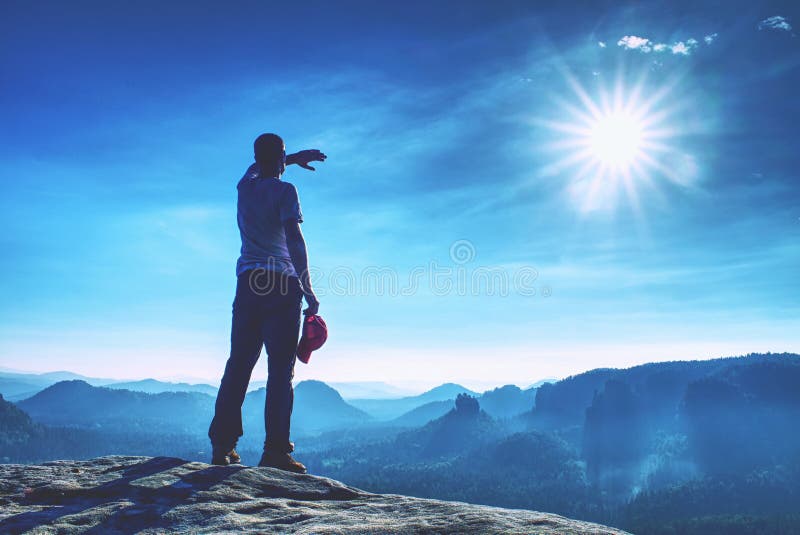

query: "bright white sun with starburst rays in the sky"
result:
(536, 73), (694, 212)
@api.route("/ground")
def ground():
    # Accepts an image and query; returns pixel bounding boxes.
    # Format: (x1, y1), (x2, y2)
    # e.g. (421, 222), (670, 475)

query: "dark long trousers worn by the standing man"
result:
(208, 269), (303, 452)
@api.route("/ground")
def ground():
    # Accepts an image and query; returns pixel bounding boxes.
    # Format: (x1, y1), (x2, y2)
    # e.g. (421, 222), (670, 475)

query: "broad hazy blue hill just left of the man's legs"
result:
(17, 380), (214, 434)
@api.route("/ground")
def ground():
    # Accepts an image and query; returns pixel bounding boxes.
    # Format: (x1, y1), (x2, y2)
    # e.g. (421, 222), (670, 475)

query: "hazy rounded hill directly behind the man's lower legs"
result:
(242, 380), (371, 441)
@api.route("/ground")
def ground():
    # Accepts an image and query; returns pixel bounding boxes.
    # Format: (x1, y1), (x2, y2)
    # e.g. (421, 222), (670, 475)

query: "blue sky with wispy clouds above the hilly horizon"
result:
(0, 1), (800, 388)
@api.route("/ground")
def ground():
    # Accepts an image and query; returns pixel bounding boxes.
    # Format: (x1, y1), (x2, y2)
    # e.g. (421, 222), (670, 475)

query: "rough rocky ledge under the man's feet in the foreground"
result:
(0, 456), (624, 535)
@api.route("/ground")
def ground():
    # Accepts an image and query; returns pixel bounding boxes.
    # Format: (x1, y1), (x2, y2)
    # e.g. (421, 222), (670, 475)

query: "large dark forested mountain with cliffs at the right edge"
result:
(519, 353), (800, 506)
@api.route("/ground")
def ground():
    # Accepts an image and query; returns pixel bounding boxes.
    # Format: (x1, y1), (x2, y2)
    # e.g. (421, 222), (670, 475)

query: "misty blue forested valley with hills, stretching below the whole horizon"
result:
(0, 354), (800, 535)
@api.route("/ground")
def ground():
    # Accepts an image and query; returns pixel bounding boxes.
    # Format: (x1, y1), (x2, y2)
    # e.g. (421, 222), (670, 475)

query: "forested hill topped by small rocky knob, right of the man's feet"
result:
(304, 396), (593, 520)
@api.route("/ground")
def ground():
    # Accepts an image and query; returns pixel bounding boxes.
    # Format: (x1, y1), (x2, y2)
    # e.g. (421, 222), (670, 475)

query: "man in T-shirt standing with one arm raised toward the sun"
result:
(208, 134), (326, 473)
